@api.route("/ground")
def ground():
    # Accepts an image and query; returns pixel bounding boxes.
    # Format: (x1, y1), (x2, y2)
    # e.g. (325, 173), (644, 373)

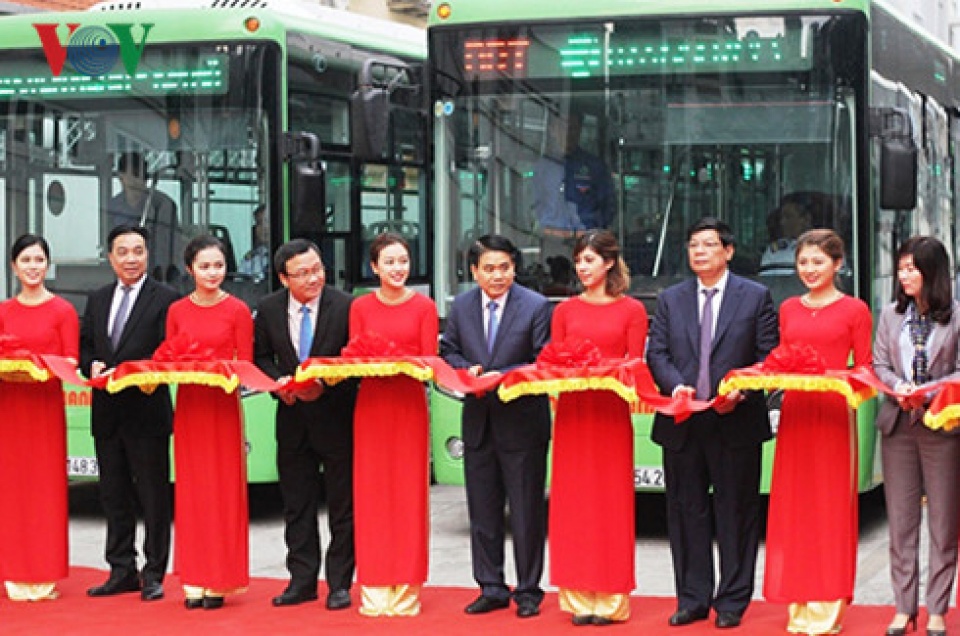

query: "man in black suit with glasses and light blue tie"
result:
(254, 239), (357, 609)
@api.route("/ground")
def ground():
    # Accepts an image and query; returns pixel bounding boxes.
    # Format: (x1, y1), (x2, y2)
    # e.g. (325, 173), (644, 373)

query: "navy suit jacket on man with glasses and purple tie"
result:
(647, 273), (780, 450)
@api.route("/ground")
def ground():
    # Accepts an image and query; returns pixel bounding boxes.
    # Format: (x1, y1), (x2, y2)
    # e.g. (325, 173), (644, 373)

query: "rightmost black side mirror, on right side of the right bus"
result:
(870, 108), (918, 210)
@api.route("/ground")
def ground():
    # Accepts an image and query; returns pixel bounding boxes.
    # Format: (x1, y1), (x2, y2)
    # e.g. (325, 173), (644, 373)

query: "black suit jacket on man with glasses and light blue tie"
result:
(253, 286), (358, 444)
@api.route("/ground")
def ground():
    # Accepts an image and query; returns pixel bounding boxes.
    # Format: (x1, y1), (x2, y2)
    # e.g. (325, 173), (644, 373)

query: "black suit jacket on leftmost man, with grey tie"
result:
(80, 277), (179, 438)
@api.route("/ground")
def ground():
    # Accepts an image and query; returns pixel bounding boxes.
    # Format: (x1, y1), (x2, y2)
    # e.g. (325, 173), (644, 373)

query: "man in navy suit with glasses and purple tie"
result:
(647, 218), (779, 628)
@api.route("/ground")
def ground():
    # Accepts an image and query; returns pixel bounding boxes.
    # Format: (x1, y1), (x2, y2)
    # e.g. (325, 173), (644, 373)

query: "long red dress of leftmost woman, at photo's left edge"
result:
(0, 297), (80, 583)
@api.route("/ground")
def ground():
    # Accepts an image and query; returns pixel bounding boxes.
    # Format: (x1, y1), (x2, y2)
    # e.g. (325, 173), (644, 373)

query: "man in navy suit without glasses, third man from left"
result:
(440, 235), (550, 618)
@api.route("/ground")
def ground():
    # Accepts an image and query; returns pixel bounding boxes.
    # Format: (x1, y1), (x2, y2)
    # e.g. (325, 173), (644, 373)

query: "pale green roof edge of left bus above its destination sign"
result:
(0, 0), (426, 59)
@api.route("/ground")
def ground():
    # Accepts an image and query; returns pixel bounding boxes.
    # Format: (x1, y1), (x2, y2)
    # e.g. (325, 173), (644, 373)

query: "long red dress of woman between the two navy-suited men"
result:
(548, 298), (647, 593)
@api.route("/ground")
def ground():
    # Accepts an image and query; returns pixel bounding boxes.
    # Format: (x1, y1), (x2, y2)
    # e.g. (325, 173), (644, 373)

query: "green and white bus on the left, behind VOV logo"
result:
(0, 0), (430, 482)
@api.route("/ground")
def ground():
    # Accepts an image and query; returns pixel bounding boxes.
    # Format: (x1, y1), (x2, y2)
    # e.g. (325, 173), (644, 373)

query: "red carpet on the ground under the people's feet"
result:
(0, 568), (928, 636)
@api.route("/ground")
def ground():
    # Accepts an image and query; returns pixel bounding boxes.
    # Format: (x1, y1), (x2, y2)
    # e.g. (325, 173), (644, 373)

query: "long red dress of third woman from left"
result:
(350, 294), (439, 586)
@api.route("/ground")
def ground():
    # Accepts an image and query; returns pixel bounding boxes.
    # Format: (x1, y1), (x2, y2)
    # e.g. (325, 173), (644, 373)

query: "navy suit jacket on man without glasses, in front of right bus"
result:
(440, 284), (552, 450)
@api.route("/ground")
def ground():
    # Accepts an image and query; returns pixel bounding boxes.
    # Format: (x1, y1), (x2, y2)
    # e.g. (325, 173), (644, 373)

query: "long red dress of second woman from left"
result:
(167, 296), (253, 590)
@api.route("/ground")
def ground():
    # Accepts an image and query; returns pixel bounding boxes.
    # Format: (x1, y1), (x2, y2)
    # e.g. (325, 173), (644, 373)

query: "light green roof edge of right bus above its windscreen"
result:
(428, 0), (870, 27)
